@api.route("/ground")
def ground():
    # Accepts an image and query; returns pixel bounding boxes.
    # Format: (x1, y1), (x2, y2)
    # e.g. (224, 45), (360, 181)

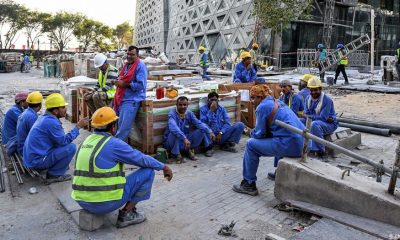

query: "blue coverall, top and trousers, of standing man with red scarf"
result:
(115, 60), (147, 141)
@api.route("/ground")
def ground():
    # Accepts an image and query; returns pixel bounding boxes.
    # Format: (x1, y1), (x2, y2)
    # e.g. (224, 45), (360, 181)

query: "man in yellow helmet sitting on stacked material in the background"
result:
(233, 52), (266, 83)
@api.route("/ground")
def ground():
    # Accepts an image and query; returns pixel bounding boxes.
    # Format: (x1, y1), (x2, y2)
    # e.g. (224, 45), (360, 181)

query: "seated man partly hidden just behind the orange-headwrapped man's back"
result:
(279, 80), (304, 117)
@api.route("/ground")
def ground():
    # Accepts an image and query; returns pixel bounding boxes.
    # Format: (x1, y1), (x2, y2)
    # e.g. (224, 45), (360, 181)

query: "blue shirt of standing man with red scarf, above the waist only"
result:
(121, 60), (147, 102)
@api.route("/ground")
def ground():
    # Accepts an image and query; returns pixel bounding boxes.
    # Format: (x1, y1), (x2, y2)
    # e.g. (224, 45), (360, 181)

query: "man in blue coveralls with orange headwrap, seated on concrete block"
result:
(233, 85), (304, 196)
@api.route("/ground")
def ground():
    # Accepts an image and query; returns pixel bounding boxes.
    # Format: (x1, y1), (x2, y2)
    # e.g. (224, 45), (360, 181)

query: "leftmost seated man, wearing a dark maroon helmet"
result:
(1, 92), (28, 145)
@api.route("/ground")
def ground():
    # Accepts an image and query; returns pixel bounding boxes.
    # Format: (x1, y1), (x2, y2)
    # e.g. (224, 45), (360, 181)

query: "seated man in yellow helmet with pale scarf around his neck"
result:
(304, 77), (339, 158)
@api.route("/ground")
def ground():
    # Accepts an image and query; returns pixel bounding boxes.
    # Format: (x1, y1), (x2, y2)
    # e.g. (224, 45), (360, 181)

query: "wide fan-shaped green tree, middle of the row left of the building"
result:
(43, 12), (84, 52)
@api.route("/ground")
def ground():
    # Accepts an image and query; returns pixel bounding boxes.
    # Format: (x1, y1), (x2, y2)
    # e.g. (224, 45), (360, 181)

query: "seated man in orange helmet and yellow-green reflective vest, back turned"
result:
(71, 107), (172, 228)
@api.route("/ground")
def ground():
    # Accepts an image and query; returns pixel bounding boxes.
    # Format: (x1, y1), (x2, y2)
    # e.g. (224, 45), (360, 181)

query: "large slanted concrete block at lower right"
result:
(274, 158), (400, 227)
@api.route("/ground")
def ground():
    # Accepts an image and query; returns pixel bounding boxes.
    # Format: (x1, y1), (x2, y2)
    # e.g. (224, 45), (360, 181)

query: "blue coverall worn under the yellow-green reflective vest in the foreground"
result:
(77, 132), (164, 214)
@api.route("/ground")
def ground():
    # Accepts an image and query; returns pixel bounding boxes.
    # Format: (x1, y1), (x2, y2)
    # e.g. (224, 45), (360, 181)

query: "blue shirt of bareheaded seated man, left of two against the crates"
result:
(164, 108), (212, 141)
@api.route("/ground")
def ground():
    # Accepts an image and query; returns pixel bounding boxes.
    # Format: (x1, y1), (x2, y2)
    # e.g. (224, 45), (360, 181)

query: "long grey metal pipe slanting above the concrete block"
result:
(275, 120), (400, 177)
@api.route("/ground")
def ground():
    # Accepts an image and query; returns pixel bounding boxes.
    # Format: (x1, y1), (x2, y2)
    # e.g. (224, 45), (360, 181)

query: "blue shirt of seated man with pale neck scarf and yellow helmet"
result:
(304, 94), (338, 125)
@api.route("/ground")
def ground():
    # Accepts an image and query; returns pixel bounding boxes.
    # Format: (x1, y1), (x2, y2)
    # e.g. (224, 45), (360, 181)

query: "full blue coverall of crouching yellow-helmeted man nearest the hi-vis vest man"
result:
(23, 112), (79, 176)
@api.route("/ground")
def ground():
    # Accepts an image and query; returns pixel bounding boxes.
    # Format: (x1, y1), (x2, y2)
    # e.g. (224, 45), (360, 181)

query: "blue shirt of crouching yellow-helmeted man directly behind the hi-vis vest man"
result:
(23, 112), (79, 168)
